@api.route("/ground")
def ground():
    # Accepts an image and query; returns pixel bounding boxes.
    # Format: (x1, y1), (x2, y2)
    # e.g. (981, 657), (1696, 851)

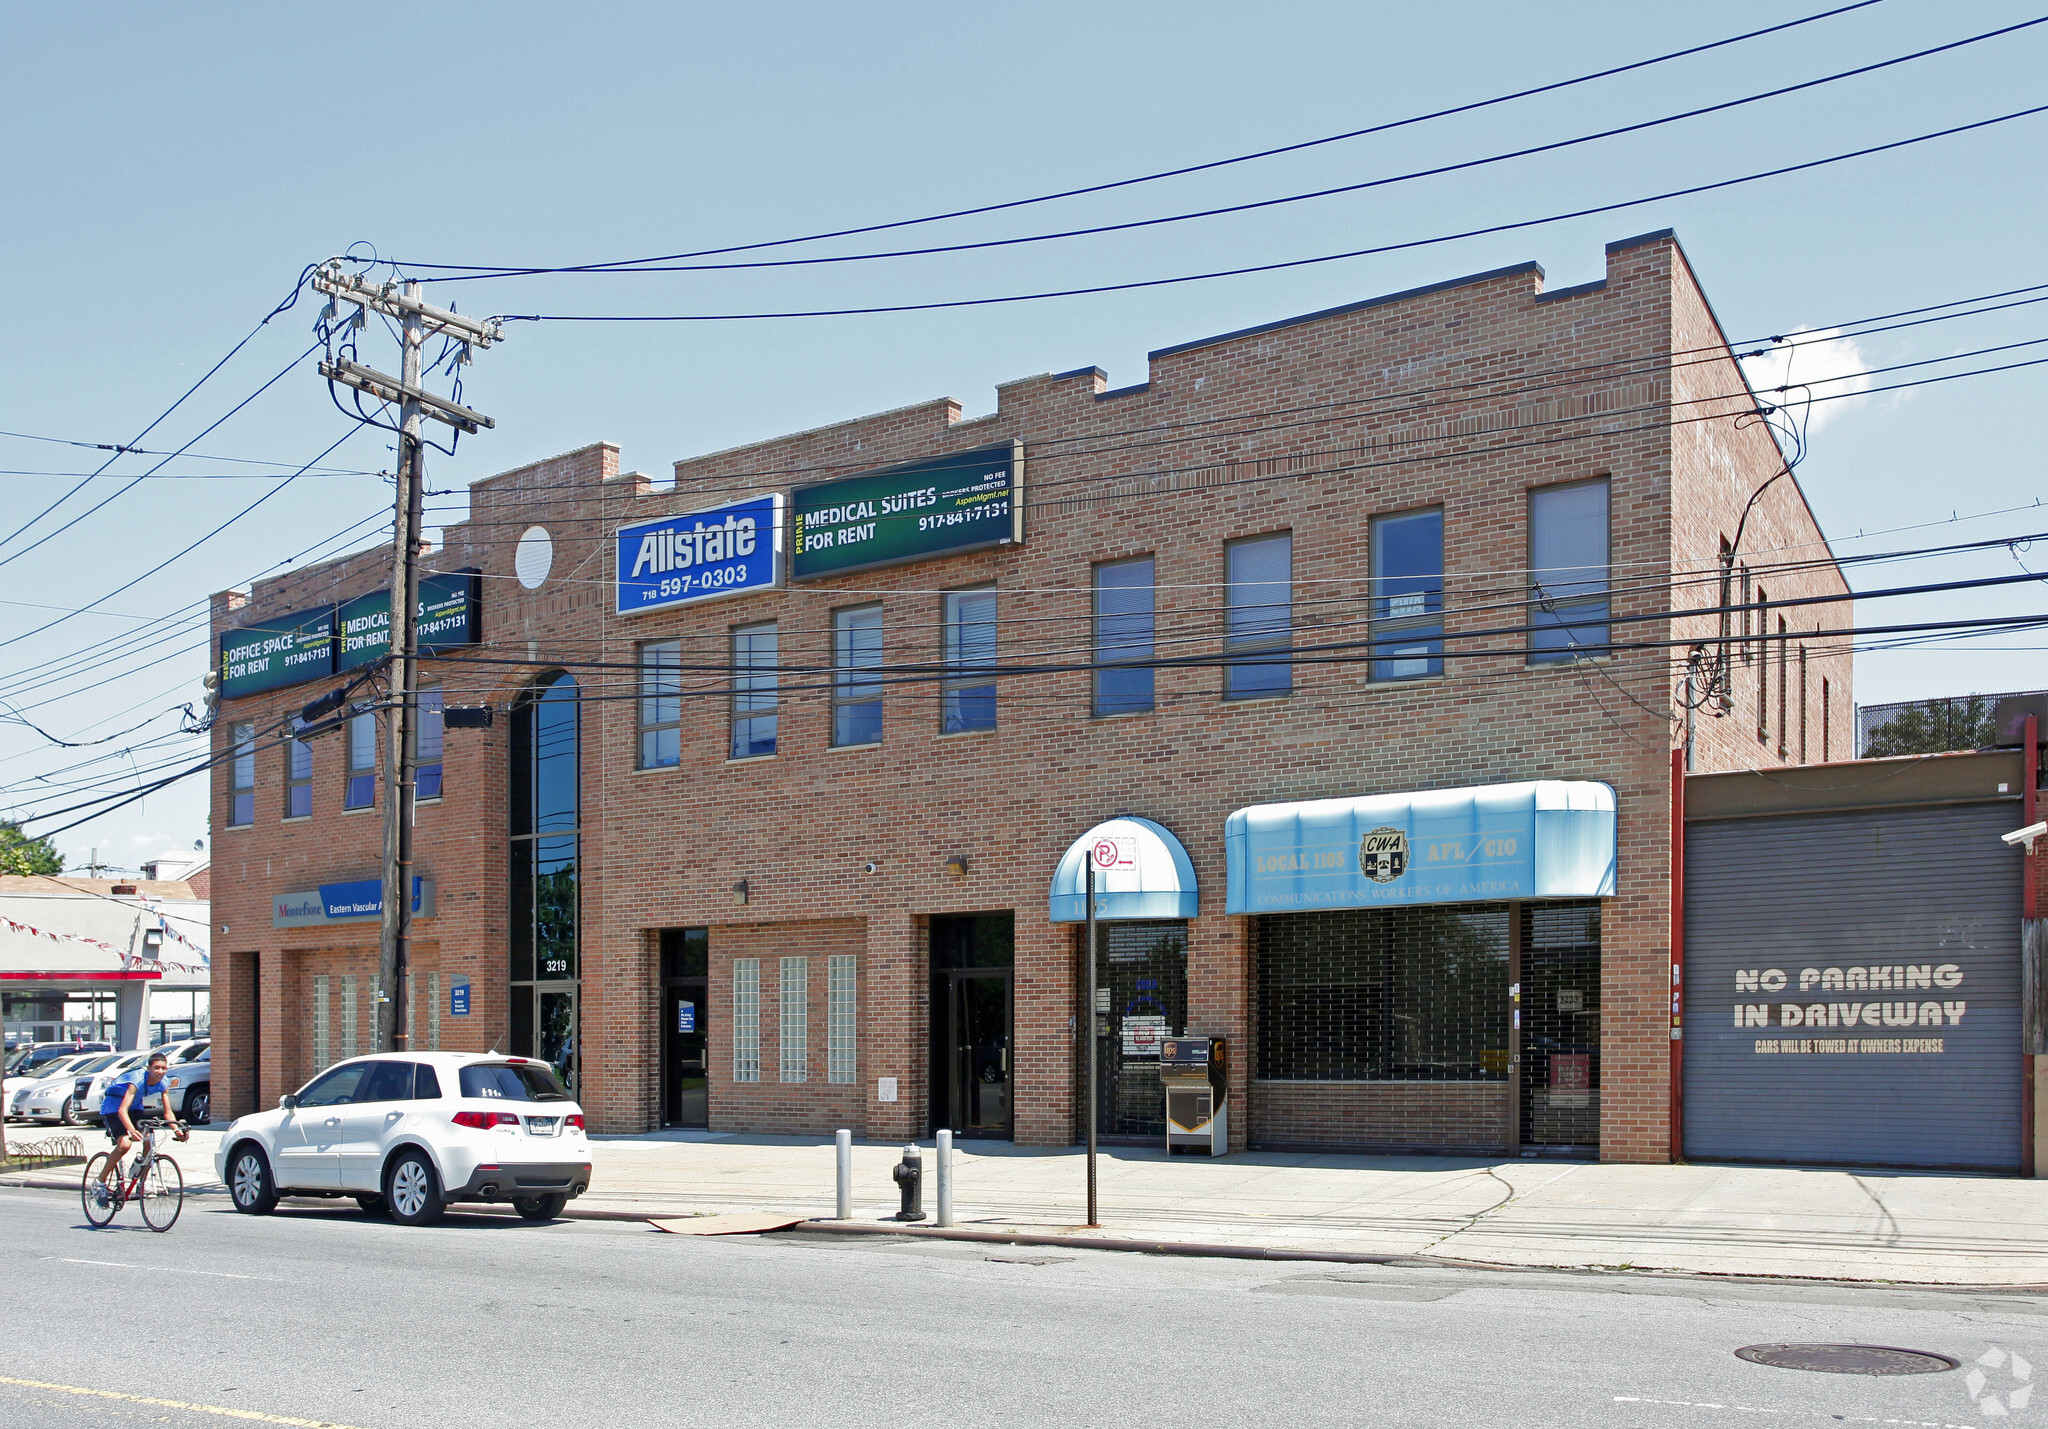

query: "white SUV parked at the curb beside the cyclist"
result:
(213, 1052), (590, 1226)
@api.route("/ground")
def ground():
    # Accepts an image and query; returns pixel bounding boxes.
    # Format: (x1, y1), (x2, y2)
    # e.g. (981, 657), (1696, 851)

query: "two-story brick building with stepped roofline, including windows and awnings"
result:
(213, 233), (1851, 1161)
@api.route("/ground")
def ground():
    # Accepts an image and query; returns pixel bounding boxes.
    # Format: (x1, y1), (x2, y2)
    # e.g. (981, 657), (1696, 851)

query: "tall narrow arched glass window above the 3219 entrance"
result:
(508, 674), (582, 1093)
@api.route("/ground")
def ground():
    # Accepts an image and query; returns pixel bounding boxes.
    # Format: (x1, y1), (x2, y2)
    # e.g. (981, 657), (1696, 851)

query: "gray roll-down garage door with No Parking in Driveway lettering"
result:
(1686, 803), (2019, 1171)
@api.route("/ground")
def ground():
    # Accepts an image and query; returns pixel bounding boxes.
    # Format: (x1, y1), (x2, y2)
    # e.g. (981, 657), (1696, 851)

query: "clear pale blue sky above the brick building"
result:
(0, 0), (2048, 866)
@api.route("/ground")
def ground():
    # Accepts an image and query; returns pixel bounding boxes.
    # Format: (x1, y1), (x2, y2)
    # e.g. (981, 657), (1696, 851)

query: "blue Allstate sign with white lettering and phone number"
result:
(616, 491), (782, 616)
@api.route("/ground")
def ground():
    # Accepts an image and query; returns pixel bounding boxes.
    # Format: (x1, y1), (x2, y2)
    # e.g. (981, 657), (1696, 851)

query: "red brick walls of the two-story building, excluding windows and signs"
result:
(213, 235), (1853, 1161)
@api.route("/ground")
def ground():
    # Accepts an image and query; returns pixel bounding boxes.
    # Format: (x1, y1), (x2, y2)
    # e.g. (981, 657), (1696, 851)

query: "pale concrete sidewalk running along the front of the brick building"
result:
(0, 1130), (2048, 1290)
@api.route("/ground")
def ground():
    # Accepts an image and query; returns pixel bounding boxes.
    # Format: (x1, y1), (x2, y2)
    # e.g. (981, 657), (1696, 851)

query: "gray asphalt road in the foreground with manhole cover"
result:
(0, 1192), (2048, 1429)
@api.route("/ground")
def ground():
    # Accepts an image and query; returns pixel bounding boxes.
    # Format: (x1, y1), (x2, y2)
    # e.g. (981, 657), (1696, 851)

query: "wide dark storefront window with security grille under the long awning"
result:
(1257, 903), (1509, 1081)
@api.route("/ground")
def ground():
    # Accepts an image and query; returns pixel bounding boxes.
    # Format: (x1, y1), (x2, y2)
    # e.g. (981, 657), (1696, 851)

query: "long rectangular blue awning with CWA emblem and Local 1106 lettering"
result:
(1223, 780), (1614, 913)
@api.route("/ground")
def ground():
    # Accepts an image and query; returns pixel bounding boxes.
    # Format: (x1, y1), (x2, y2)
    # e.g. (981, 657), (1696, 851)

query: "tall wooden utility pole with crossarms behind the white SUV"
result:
(313, 262), (502, 1052)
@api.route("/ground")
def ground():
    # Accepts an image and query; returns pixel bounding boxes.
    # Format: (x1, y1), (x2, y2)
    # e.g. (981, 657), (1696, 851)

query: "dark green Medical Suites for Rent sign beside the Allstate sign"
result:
(788, 442), (1024, 581)
